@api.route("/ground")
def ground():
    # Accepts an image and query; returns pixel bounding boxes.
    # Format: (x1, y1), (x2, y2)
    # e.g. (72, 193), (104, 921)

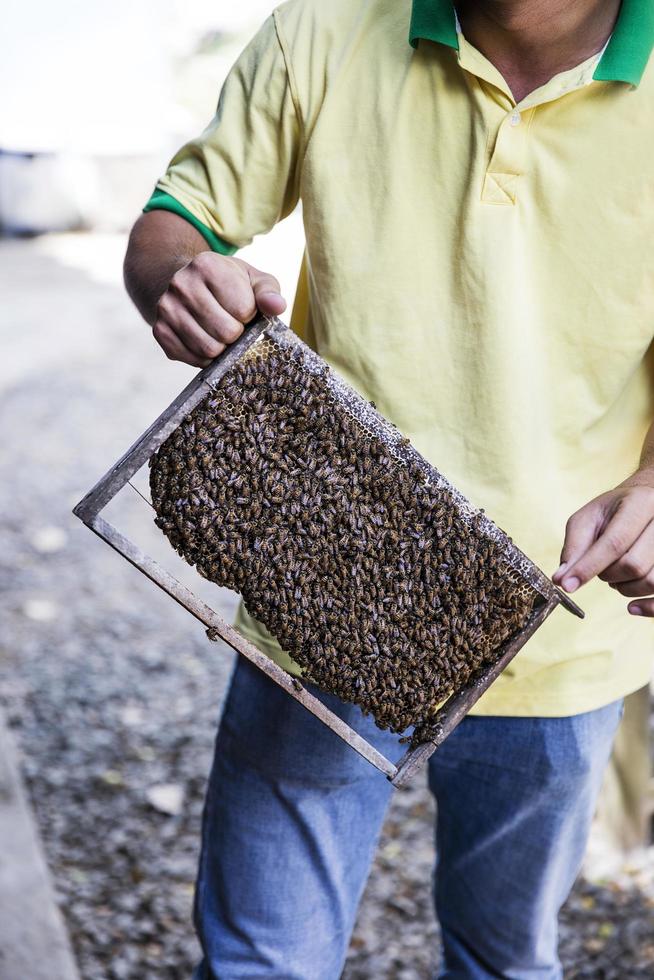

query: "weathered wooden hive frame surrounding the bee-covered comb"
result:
(73, 316), (583, 786)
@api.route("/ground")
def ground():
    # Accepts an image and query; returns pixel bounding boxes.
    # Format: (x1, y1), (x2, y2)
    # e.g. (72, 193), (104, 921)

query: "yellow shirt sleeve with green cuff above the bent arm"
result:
(144, 15), (301, 254)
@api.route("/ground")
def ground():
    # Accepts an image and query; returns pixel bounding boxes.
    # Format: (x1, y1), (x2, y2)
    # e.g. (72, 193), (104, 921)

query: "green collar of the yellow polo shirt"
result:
(409, 0), (654, 85)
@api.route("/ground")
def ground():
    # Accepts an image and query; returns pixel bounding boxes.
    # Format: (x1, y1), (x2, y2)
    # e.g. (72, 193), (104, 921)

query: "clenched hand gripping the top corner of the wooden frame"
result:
(152, 252), (286, 367)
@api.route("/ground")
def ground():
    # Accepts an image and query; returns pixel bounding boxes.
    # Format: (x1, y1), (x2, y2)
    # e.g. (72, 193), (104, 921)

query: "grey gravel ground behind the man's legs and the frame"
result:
(0, 236), (654, 980)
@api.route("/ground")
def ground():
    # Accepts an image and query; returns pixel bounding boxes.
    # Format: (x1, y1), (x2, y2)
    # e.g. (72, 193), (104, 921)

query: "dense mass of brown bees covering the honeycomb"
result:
(150, 342), (539, 744)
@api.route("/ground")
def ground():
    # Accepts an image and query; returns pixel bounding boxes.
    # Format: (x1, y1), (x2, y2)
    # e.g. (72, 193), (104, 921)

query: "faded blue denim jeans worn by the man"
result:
(194, 659), (621, 980)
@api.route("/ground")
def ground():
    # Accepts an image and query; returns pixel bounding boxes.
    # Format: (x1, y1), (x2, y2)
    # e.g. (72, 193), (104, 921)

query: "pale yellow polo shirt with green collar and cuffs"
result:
(146, 0), (654, 715)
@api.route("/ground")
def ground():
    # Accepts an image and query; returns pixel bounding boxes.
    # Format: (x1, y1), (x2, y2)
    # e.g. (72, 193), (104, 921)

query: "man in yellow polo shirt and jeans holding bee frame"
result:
(126, 0), (654, 980)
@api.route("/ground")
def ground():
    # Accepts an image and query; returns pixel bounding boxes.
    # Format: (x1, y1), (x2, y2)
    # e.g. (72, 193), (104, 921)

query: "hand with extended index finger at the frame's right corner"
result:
(552, 469), (654, 616)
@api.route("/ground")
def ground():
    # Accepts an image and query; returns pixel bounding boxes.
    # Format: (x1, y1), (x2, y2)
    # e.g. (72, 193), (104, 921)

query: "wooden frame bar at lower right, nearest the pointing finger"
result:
(391, 593), (562, 786)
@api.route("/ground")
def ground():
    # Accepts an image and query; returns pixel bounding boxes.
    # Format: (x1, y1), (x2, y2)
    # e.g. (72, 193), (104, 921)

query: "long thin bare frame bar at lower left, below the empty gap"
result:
(85, 515), (397, 779)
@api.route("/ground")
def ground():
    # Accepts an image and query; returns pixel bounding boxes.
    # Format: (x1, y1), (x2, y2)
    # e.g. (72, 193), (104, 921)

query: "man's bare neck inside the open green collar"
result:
(456, 0), (620, 102)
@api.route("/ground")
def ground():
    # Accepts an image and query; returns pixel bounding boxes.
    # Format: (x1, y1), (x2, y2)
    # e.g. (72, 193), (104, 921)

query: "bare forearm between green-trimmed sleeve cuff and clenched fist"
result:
(123, 211), (208, 326)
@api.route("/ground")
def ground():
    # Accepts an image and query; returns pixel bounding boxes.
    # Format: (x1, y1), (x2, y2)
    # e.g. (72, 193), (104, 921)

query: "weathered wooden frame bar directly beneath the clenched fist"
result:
(73, 316), (270, 524)
